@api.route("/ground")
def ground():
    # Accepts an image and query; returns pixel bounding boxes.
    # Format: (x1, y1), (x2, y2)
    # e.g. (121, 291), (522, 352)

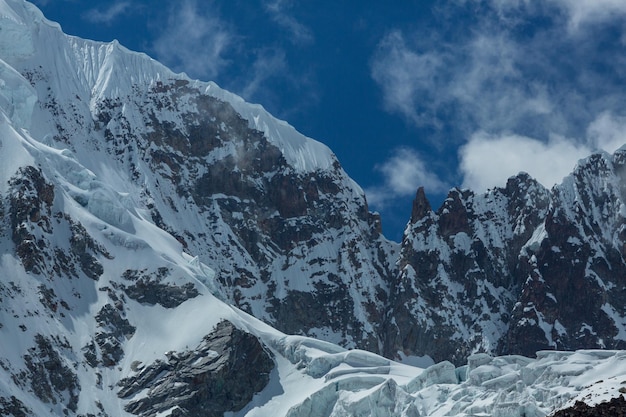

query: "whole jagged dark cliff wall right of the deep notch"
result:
(385, 149), (626, 362)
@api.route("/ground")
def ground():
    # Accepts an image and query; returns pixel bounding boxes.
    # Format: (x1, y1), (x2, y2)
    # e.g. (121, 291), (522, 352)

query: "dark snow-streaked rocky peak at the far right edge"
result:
(500, 149), (626, 354)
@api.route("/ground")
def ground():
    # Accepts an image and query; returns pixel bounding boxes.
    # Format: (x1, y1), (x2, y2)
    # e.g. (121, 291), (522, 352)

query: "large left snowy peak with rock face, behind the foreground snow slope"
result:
(0, 0), (397, 351)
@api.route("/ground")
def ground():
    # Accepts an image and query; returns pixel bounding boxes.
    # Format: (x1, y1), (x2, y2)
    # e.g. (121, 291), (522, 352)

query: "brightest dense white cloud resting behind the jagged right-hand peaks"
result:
(459, 132), (591, 192)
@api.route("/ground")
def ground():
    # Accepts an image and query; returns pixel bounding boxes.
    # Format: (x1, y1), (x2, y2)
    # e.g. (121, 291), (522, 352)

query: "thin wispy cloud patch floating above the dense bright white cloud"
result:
(372, 25), (566, 138)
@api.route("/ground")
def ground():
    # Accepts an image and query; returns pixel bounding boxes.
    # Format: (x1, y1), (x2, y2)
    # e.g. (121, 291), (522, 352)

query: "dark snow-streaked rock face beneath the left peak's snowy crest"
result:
(88, 80), (394, 350)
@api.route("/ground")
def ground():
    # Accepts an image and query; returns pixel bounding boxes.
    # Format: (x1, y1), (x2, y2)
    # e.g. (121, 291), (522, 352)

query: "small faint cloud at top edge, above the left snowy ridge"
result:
(152, 0), (235, 79)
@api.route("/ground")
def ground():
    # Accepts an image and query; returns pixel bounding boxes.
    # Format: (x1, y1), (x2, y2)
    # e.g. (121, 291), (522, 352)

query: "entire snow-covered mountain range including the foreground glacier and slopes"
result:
(0, 0), (626, 417)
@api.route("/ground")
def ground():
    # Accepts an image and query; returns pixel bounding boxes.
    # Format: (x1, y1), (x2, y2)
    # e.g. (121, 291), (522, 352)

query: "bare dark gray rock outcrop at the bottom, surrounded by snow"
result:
(118, 321), (274, 417)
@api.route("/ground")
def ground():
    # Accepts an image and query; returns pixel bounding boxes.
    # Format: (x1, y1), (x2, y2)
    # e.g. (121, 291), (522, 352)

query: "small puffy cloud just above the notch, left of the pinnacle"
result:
(365, 148), (448, 209)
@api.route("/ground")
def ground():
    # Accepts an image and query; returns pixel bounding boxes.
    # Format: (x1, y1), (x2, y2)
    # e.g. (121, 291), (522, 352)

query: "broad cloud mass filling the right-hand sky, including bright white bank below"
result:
(371, 0), (626, 190)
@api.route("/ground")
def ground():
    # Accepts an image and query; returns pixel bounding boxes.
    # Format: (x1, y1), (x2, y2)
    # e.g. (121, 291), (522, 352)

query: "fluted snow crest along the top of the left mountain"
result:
(0, 0), (336, 172)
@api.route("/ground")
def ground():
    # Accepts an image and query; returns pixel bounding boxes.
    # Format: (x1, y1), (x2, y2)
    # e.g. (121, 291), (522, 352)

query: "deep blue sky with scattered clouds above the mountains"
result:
(33, 0), (626, 240)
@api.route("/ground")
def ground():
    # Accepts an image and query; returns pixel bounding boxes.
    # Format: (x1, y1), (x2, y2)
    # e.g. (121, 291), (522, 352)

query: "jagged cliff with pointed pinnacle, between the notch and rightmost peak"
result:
(386, 174), (549, 361)
